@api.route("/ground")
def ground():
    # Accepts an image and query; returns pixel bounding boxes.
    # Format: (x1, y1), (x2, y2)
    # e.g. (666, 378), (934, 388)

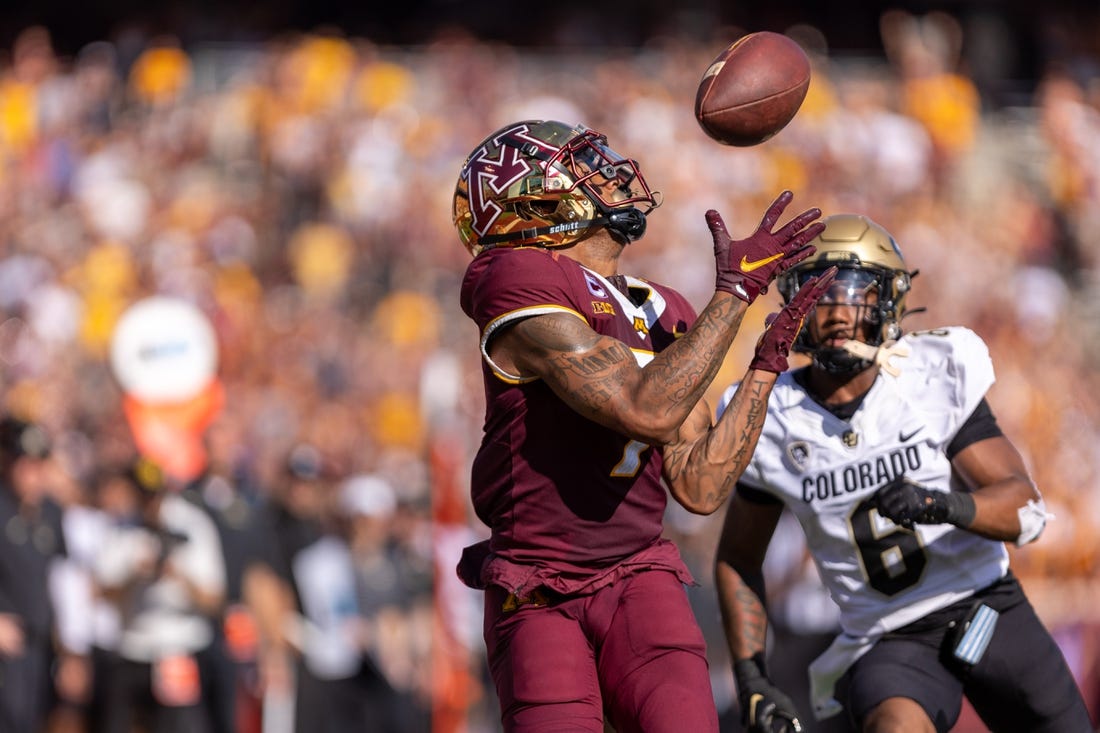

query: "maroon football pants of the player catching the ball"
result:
(485, 570), (718, 733)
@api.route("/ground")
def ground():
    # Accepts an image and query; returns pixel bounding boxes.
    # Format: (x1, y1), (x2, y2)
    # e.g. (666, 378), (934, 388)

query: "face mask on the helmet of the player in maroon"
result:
(547, 130), (660, 214)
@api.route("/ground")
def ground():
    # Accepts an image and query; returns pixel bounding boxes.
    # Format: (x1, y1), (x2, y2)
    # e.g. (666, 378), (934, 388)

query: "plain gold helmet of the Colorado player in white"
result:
(777, 214), (916, 373)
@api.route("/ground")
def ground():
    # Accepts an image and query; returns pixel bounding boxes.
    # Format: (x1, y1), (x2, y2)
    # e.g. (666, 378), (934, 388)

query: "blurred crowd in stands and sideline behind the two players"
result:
(0, 11), (1100, 733)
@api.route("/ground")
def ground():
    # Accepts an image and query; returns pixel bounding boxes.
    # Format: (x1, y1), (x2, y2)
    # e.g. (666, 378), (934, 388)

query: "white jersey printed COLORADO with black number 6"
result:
(721, 327), (1009, 637)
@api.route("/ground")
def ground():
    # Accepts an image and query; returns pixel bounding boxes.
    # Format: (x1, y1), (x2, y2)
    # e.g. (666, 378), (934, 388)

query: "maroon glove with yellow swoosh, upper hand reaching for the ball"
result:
(706, 190), (825, 303)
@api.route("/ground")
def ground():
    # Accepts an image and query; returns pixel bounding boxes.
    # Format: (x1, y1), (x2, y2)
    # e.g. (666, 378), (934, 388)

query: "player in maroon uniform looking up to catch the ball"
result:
(454, 120), (833, 733)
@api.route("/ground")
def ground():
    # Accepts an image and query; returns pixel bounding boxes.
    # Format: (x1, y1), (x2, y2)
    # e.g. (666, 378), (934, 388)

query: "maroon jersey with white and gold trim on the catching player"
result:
(460, 248), (695, 592)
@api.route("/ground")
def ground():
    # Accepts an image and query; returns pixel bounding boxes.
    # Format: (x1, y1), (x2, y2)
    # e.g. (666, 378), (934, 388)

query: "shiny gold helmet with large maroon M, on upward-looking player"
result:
(452, 120), (660, 255)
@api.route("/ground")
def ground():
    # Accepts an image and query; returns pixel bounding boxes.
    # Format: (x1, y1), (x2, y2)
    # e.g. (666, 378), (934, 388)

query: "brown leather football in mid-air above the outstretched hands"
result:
(695, 31), (810, 147)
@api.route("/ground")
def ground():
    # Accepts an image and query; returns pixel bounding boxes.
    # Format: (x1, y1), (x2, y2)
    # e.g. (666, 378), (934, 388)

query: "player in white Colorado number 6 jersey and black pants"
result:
(715, 215), (1095, 733)
